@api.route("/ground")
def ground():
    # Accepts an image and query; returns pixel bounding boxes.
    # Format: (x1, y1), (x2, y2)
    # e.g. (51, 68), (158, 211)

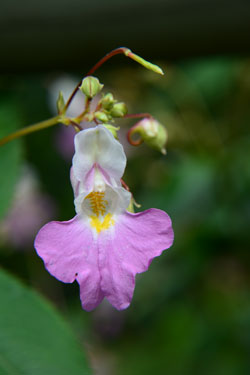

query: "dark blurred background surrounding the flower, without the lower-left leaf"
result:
(0, 0), (250, 375)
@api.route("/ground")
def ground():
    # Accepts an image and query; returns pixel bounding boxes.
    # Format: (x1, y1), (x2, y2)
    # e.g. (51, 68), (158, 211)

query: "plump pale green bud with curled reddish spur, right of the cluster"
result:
(128, 118), (168, 155)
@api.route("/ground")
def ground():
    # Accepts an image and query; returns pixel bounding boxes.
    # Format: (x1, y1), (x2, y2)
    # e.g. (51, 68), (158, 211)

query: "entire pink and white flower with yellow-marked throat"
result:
(35, 125), (173, 311)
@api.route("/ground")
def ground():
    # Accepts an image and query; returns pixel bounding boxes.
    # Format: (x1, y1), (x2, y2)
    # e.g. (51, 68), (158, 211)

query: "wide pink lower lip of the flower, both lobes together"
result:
(35, 209), (174, 311)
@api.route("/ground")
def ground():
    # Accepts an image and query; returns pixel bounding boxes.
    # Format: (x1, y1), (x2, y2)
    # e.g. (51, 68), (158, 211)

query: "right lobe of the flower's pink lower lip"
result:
(99, 208), (174, 310)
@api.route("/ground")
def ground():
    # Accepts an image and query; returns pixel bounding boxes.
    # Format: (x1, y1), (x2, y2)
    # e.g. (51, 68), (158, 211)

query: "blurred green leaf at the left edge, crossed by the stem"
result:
(0, 100), (21, 218)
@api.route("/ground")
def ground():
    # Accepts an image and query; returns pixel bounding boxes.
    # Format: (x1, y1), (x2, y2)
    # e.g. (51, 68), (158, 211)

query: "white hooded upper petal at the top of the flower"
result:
(73, 125), (126, 182)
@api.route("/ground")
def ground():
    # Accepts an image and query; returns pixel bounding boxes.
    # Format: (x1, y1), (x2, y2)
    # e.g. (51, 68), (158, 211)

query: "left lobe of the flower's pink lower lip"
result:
(35, 216), (104, 311)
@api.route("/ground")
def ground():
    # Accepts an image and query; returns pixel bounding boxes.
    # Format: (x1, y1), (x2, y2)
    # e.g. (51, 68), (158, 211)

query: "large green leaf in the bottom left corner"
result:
(0, 270), (90, 375)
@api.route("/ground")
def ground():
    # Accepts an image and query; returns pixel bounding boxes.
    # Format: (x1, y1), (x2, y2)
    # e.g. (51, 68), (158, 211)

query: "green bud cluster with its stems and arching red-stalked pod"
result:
(0, 47), (170, 154)
